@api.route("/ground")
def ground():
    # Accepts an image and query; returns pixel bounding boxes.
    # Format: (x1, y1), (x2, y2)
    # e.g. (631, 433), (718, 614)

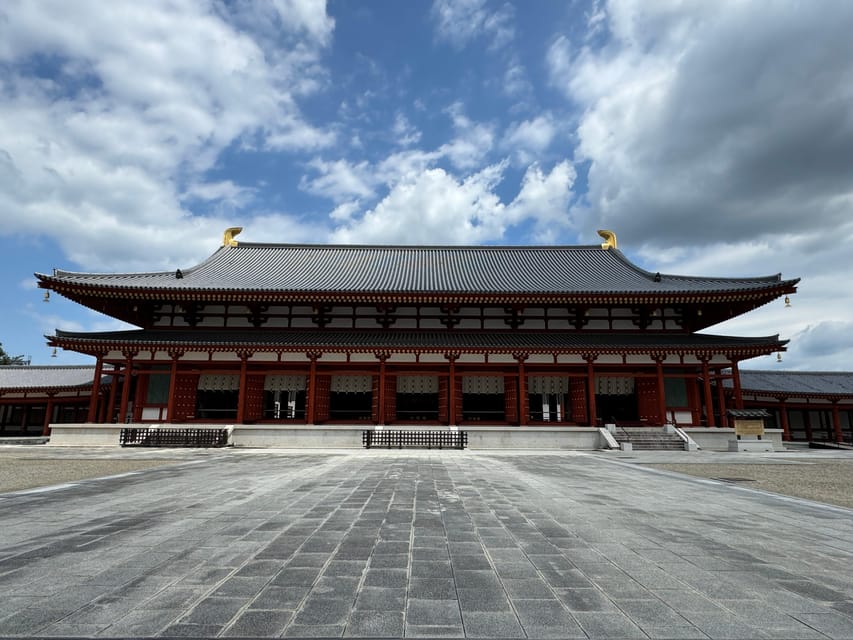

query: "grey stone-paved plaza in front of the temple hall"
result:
(0, 450), (853, 638)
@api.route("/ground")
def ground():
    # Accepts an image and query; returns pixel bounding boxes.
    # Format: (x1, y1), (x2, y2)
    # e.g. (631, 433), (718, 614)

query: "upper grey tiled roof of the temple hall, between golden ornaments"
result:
(37, 243), (797, 294)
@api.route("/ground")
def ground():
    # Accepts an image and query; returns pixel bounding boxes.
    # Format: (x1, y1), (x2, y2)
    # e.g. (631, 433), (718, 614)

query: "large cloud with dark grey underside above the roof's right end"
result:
(547, 1), (853, 246)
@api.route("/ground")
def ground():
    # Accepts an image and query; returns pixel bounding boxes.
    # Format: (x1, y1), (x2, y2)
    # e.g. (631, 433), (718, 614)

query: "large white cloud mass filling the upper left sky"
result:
(0, 0), (334, 269)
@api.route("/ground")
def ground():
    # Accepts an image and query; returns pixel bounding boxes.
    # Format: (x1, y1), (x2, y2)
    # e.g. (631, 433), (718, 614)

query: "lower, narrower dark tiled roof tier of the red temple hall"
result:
(56, 329), (786, 352)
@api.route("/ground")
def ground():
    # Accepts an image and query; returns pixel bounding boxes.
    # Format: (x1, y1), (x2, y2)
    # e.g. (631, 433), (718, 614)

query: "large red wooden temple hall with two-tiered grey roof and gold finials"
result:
(36, 228), (798, 442)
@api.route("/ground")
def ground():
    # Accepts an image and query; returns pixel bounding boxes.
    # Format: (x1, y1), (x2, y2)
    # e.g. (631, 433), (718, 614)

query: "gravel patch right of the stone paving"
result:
(647, 460), (853, 508)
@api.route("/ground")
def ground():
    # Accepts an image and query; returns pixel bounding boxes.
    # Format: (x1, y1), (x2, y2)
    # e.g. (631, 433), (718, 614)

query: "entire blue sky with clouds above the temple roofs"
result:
(0, 0), (853, 370)
